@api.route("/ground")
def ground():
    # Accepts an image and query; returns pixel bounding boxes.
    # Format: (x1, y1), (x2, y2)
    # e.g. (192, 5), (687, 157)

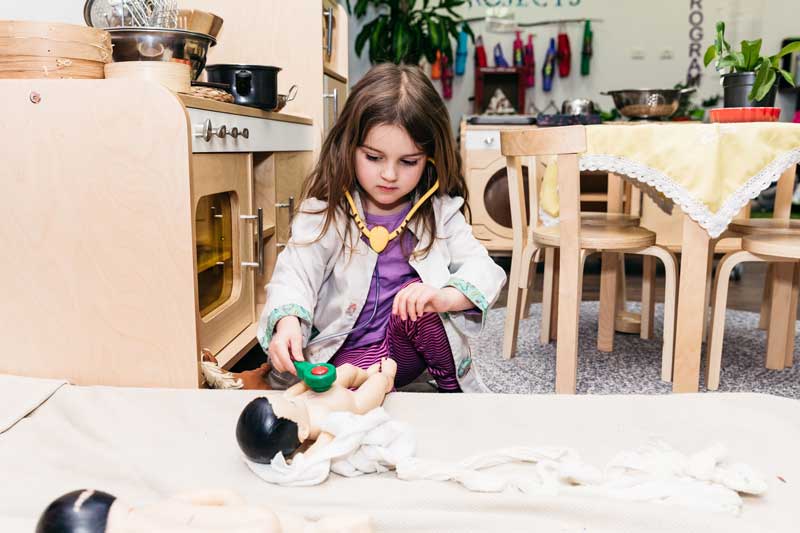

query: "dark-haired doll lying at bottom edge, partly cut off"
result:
(36, 490), (373, 533)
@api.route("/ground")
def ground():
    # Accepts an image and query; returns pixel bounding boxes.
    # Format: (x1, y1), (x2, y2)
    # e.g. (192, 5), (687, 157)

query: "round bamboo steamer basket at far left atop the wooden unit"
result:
(0, 20), (111, 79)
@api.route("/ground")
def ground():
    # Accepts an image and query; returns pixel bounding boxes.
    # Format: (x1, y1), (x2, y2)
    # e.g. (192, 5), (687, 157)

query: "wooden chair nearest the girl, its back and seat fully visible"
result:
(500, 126), (677, 393)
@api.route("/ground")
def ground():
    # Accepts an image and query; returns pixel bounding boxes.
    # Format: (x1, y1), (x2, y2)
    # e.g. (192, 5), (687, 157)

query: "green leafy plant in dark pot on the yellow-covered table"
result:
(703, 22), (800, 107)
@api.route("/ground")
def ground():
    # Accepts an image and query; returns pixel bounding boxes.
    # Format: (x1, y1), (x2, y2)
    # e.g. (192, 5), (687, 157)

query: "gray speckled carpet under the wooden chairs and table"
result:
(472, 302), (800, 398)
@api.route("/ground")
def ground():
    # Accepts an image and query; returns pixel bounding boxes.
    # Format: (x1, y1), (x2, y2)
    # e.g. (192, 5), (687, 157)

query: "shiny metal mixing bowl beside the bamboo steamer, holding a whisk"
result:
(106, 28), (217, 80)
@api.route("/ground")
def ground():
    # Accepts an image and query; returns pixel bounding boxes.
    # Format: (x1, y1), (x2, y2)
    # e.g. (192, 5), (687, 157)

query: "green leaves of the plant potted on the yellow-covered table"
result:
(703, 22), (800, 101)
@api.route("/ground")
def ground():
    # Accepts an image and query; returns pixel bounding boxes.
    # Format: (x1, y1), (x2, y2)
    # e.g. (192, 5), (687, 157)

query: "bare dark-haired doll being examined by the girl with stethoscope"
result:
(236, 358), (397, 464)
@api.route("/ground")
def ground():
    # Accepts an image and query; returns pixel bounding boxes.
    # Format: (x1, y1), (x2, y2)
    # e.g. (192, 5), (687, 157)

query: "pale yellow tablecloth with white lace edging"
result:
(541, 122), (800, 237)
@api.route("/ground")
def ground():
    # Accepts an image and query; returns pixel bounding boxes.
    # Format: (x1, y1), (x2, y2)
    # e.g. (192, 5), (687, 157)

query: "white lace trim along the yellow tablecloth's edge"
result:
(580, 152), (800, 238)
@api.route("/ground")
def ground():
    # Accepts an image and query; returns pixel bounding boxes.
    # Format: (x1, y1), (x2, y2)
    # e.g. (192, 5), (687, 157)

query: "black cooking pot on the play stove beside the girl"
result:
(206, 65), (281, 111)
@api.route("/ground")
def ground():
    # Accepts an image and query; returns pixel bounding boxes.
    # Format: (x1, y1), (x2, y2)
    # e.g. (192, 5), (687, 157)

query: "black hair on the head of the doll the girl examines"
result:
(236, 397), (300, 464)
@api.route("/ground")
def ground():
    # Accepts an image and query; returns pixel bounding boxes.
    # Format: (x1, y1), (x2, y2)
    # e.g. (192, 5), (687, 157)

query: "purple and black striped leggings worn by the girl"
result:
(329, 313), (461, 392)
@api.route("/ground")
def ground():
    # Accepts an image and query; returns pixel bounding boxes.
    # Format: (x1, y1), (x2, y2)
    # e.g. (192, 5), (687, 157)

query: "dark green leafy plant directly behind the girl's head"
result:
(347, 0), (475, 65)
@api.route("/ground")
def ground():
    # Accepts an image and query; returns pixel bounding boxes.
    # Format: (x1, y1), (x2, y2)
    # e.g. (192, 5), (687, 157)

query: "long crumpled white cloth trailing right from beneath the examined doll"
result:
(245, 408), (767, 514)
